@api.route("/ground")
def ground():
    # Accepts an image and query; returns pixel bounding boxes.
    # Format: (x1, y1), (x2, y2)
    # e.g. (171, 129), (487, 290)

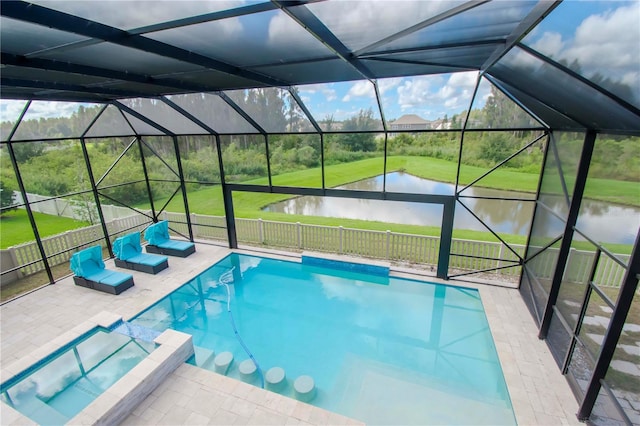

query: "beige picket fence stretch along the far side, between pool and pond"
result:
(164, 213), (629, 287)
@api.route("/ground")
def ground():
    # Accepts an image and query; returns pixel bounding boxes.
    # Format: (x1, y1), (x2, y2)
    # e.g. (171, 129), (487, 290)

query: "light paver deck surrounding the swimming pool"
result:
(0, 244), (581, 425)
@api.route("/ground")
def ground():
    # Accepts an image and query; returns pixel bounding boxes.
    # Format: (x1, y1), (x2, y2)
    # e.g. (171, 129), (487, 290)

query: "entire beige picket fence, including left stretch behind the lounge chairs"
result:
(2, 210), (629, 287)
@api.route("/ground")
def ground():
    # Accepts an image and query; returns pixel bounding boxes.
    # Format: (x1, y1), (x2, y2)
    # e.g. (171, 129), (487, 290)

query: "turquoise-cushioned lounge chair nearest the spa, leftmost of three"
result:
(69, 246), (133, 294)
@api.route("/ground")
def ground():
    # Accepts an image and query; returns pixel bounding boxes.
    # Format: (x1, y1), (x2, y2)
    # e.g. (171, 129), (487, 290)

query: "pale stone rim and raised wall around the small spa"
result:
(2, 311), (194, 425)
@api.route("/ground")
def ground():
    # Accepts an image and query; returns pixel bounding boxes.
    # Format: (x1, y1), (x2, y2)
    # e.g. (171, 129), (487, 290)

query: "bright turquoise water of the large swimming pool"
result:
(132, 254), (515, 425)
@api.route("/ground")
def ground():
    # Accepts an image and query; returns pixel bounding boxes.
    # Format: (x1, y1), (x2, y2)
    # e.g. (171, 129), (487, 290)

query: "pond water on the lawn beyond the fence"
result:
(265, 172), (640, 244)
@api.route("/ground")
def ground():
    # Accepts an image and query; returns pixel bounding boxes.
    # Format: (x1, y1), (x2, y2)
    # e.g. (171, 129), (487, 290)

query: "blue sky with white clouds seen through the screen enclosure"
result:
(0, 0), (640, 126)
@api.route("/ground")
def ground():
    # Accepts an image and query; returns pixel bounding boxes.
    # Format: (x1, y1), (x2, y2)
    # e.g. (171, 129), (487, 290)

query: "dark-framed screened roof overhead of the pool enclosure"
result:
(0, 0), (640, 133)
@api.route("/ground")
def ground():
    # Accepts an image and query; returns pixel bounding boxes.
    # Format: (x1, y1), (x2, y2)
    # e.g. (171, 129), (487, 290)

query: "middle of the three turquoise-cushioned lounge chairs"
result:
(113, 232), (169, 274)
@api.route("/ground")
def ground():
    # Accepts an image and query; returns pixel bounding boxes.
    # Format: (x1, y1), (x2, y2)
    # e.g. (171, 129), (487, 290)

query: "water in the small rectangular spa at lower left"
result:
(0, 328), (155, 425)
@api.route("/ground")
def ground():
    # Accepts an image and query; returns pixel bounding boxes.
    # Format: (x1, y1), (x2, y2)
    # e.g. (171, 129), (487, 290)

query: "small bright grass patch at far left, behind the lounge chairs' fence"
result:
(0, 209), (89, 249)
